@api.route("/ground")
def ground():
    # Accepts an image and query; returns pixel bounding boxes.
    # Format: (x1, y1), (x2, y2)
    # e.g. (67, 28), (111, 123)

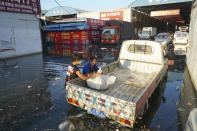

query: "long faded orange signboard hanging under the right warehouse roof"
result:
(151, 9), (180, 17)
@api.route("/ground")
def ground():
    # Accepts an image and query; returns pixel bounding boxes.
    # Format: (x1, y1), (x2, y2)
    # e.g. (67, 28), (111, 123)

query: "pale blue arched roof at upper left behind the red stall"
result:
(45, 6), (87, 17)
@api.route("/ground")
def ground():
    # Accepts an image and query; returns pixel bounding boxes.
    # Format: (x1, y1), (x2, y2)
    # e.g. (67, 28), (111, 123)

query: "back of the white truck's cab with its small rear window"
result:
(119, 40), (164, 64)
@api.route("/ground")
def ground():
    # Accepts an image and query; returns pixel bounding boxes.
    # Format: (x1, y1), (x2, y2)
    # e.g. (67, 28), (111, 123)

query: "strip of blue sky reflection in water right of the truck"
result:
(149, 71), (183, 131)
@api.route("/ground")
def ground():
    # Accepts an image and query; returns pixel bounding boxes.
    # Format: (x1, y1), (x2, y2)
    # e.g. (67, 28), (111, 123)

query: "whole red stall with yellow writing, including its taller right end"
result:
(43, 19), (104, 58)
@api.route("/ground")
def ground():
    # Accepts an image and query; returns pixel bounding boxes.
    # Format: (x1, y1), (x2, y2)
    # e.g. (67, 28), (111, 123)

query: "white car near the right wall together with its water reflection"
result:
(173, 31), (189, 55)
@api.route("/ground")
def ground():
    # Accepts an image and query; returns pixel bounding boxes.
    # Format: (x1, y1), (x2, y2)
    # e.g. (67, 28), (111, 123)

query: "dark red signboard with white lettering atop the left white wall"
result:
(0, 0), (40, 15)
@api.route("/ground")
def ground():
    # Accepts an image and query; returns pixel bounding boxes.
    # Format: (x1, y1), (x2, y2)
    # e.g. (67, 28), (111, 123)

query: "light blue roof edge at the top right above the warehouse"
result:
(131, 0), (192, 7)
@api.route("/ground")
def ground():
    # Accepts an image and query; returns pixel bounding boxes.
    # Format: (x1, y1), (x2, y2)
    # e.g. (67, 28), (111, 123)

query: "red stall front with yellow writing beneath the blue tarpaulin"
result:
(47, 31), (89, 57)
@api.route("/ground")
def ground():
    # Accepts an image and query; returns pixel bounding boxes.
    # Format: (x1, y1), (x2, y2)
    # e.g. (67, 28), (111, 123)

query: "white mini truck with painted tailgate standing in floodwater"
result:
(66, 40), (168, 128)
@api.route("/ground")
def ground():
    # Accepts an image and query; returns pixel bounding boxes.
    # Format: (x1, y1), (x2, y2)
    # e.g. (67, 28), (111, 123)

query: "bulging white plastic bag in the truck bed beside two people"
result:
(86, 75), (116, 90)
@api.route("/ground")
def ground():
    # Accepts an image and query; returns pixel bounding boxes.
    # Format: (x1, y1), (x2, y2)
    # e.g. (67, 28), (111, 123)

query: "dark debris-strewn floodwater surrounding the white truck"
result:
(0, 47), (197, 131)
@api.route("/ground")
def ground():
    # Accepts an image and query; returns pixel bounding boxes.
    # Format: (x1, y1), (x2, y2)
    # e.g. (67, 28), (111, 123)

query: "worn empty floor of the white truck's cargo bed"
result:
(99, 68), (156, 102)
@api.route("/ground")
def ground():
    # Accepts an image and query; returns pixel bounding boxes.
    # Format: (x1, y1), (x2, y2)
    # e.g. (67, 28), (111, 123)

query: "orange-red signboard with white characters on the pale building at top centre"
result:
(100, 11), (123, 20)
